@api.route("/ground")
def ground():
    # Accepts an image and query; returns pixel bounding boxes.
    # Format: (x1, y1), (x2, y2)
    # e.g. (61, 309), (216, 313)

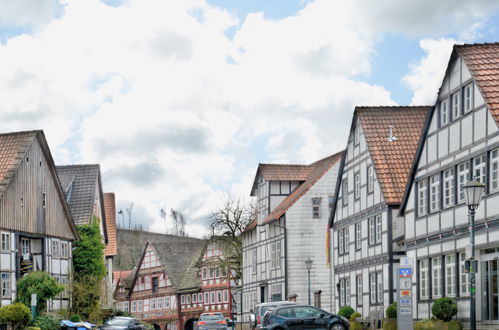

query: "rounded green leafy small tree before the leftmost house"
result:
(17, 271), (64, 312)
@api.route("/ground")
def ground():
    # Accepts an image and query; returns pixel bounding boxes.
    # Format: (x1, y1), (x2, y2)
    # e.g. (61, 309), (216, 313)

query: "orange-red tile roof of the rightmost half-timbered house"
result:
(454, 42), (499, 125)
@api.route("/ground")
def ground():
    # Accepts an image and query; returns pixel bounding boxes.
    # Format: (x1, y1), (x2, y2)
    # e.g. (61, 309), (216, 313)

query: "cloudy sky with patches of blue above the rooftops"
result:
(0, 0), (499, 236)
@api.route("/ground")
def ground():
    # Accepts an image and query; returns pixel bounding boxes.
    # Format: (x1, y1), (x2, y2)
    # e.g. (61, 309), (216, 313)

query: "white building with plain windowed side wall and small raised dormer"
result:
(242, 153), (341, 322)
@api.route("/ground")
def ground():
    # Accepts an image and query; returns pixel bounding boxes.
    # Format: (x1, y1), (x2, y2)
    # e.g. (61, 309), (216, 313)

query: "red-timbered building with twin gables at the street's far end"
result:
(114, 236), (235, 329)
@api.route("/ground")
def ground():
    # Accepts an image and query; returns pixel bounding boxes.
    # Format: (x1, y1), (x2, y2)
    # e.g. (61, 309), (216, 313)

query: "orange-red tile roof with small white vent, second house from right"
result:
(355, 106), (431, 205)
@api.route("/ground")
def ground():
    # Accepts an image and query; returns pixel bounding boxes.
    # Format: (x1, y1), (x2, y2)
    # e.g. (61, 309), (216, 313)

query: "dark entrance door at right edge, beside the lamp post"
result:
(482, 260), (499, 321)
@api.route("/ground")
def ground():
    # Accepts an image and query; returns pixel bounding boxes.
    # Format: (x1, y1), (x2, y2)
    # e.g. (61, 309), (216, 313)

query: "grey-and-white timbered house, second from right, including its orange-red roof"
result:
(330, 107), (429, 317)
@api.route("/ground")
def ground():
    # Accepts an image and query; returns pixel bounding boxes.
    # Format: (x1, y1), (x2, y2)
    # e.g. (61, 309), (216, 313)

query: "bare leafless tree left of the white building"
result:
(210, 197), (255, 280)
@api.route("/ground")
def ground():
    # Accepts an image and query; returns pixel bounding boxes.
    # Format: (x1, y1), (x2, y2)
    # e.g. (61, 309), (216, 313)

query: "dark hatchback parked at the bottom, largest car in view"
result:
(262, 305), (350, 330)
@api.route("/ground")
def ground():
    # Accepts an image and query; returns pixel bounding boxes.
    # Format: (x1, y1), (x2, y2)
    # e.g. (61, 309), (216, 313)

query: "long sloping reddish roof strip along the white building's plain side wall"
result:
(262, 152), (342, 224)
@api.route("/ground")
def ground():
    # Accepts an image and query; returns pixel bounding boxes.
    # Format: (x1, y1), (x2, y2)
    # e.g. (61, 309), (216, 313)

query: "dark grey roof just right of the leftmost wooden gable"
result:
(56, 165), (104, 225)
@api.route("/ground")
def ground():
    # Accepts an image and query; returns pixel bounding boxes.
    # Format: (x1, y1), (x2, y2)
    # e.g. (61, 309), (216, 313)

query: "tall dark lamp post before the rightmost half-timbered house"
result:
(463, 180), (485, 330)
